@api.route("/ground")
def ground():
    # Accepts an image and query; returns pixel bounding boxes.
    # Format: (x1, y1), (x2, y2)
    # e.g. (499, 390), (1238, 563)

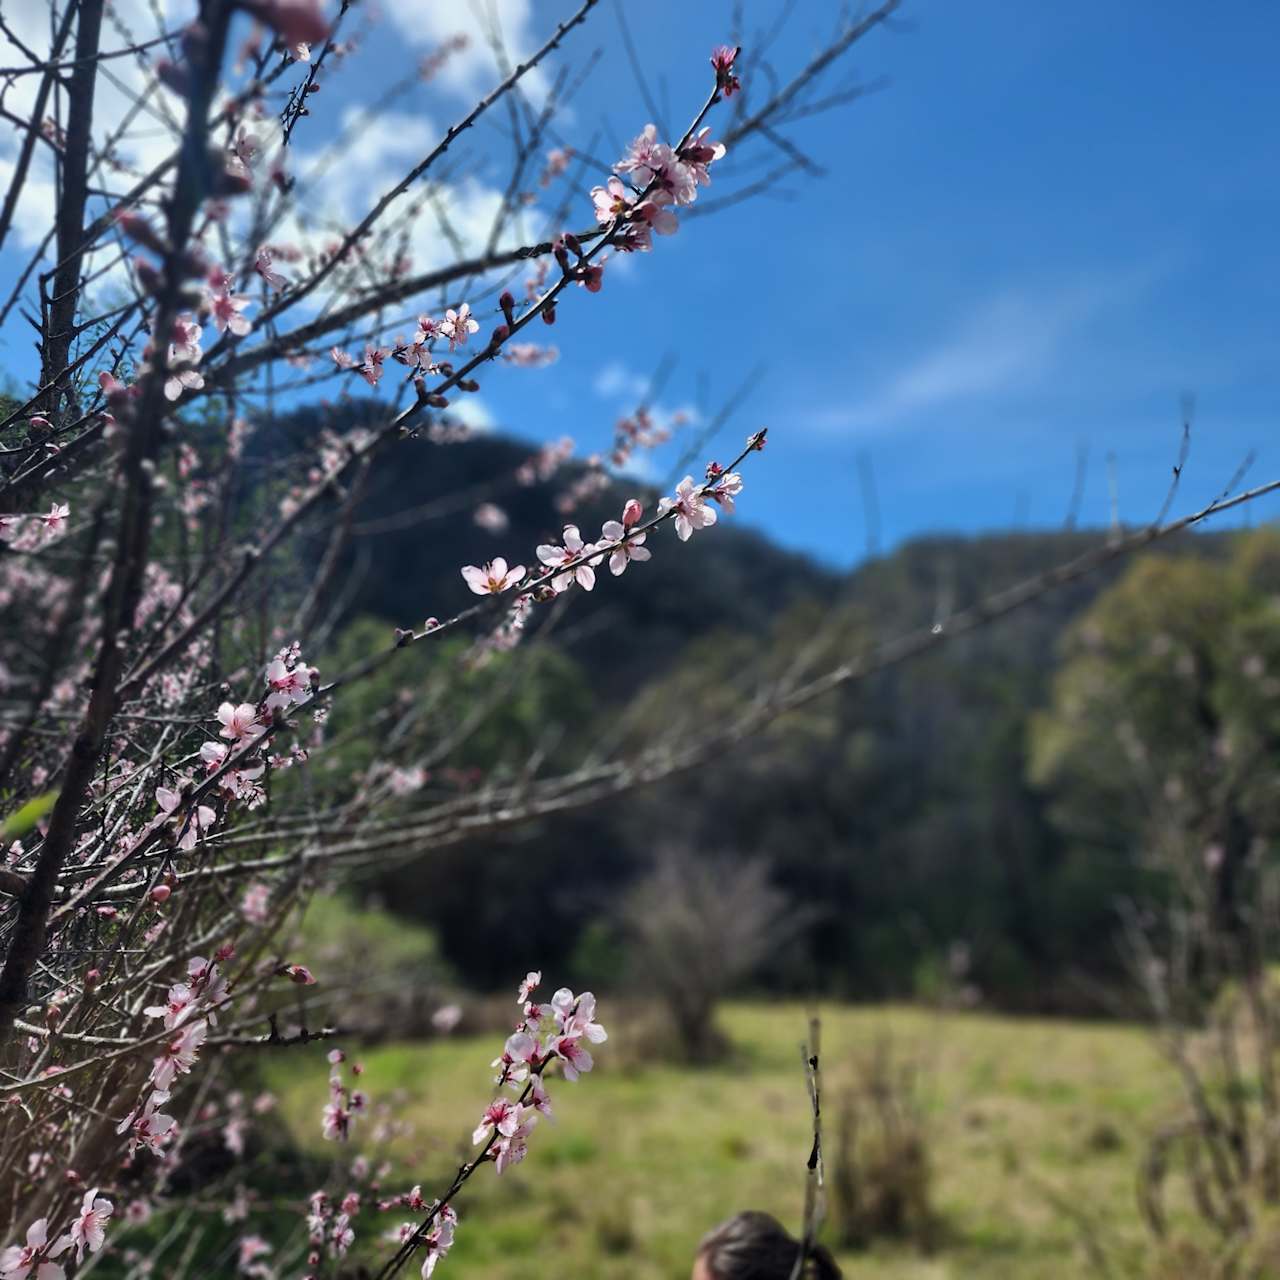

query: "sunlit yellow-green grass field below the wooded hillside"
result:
(270, 1005), (1178, 1280)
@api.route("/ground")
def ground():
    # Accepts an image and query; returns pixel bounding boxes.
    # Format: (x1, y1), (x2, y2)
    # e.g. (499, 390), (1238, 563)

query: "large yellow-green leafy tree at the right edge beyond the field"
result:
(1030, 531), (1280, 959)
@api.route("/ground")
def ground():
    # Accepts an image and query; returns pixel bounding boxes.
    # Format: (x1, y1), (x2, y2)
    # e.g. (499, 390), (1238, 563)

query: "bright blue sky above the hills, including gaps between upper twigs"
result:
(0, 0), (1280, 563)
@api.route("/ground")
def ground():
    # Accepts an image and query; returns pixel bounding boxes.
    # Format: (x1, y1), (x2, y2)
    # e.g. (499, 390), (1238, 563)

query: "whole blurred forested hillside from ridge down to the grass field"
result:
(267, 401), (1234, 1010)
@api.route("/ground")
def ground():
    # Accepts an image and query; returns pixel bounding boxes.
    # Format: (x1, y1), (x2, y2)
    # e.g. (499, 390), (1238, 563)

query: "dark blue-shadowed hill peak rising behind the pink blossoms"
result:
(270, 410), (838, 699)
